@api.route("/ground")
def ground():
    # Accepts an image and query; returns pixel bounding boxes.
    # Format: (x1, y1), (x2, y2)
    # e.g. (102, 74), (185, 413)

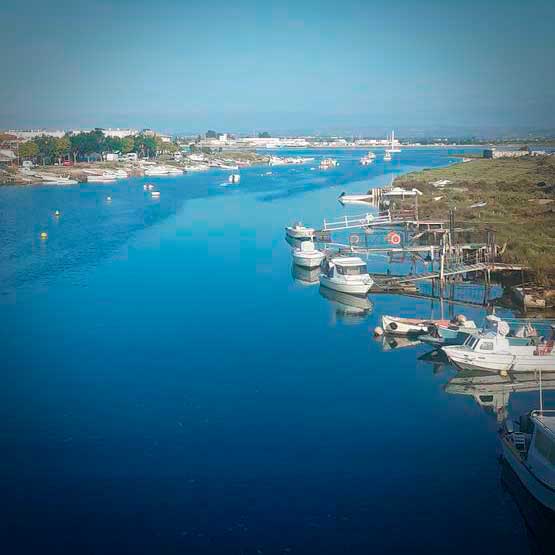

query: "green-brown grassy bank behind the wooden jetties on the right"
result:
(395, 156), (555, 283)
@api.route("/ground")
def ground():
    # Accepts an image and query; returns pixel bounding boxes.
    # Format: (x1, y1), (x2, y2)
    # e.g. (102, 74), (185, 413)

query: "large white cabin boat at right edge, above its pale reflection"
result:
(442, 321), (555, 372)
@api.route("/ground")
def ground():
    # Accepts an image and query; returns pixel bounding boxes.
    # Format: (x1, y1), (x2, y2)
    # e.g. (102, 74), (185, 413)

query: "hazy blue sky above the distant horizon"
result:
(0, 0), (555, 135)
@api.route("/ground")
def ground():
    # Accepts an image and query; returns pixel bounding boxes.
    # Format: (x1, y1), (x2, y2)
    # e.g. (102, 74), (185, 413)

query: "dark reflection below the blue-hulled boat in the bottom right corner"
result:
(499, 450), (555, 555)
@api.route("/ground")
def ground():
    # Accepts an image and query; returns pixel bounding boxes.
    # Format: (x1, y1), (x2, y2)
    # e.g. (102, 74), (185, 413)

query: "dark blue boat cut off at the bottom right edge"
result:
(499, 408), (555, 511)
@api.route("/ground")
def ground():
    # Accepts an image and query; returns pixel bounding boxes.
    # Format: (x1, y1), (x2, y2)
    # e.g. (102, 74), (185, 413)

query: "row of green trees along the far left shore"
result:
(19, 129), (179, 164)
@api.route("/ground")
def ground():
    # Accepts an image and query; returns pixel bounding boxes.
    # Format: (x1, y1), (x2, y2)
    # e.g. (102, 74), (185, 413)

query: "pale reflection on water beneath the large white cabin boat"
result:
(445, 370), (555, 423)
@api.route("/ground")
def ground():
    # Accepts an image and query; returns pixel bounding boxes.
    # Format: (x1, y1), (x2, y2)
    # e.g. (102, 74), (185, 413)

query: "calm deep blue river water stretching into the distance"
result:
(0, 150), (549, 554)
